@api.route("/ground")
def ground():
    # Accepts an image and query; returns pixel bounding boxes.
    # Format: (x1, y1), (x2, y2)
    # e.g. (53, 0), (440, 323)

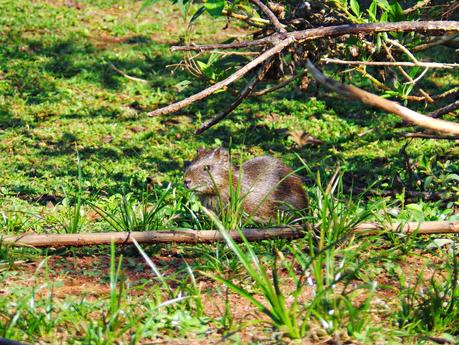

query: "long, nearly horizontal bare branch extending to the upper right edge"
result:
(171, 21), (459, 51)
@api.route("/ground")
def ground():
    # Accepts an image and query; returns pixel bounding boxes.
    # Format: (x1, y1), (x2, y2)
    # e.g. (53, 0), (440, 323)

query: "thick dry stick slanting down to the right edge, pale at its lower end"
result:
(307, 60), (459, 135)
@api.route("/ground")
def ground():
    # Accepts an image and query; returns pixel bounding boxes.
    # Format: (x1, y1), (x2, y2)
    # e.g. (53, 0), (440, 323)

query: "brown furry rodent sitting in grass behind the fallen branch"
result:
(185, 148), (307, 222)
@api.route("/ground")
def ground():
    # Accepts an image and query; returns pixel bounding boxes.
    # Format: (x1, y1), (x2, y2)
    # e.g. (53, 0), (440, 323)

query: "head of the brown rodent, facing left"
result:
(185, 147), (231, 195)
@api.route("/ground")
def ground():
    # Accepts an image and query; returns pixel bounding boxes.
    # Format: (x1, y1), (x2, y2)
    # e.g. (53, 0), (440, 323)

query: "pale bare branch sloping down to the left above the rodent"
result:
(148, 38), (293, 116)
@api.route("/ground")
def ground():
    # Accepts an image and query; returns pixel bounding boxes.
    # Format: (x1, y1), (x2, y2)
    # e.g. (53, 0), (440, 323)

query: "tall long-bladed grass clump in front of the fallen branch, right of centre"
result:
(203, 165), (376, 339)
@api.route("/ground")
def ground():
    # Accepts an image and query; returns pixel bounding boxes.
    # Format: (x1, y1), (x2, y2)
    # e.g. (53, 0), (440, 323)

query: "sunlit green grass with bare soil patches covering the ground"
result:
(0, 0), (459, 344)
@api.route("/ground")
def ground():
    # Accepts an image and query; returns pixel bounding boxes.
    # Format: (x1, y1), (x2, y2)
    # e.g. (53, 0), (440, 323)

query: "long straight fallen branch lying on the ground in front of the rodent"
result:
(1, 221), (459, 248)
